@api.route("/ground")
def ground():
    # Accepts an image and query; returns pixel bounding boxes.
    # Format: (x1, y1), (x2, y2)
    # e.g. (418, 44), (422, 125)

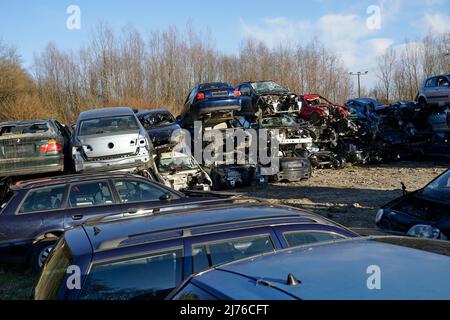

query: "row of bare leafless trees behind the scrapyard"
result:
(0, 24), (448, 124)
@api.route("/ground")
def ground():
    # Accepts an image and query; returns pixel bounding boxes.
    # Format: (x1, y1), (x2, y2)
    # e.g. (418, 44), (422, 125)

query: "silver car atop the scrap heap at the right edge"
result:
(417, 74), (450, 107)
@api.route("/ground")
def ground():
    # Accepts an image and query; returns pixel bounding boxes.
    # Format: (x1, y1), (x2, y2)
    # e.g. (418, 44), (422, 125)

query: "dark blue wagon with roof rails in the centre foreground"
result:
(35, 200), (357, 300)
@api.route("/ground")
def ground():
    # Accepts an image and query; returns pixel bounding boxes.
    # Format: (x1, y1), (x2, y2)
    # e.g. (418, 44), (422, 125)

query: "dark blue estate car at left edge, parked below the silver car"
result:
(0, 173), (224, 270)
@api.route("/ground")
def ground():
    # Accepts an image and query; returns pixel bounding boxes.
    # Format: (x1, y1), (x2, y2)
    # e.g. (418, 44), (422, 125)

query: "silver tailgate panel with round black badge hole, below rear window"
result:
(78, 131), (147, 158)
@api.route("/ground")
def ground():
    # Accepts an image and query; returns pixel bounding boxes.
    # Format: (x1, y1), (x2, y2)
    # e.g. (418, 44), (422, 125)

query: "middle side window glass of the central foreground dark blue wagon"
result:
(192, 235), (275, 273)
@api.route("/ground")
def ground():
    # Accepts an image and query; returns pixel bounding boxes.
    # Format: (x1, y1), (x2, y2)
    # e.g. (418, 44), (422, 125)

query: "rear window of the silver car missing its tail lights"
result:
(78, 116), (139, 136)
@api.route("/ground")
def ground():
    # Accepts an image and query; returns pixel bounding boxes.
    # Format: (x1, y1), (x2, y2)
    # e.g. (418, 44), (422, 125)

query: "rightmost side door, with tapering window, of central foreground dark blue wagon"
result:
(274, 224), (357, 248)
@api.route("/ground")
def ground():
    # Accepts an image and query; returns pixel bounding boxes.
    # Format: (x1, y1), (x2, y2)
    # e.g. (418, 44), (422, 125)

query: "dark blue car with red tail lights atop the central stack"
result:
(178, 82), (241, 128)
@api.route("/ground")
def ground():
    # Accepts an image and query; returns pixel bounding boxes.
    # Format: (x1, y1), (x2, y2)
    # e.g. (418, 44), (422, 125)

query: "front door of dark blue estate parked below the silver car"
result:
(112, 178), (189, 215)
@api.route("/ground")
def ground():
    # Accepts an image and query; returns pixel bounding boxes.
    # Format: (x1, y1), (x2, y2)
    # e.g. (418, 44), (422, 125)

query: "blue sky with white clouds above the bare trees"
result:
(0, 0), (450, 87)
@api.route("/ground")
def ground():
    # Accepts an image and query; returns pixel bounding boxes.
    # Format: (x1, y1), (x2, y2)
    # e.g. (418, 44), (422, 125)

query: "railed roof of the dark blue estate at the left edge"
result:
(10, 171), (159, 190)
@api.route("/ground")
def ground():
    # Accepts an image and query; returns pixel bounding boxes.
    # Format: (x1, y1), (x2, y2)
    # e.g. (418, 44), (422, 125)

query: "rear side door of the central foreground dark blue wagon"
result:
(184, 227), (281, 277)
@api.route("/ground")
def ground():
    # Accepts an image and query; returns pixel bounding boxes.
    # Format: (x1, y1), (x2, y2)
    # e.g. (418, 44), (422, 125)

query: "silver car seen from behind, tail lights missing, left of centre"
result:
(72, 107), (152, 172)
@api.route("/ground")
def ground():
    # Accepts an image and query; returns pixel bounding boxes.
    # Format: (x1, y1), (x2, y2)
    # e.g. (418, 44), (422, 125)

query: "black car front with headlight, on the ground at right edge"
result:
(375, 170), (450, 239)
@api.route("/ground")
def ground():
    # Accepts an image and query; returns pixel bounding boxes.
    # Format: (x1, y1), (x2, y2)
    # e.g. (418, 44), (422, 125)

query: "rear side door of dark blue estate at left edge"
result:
(64, 180), (122, 228)
